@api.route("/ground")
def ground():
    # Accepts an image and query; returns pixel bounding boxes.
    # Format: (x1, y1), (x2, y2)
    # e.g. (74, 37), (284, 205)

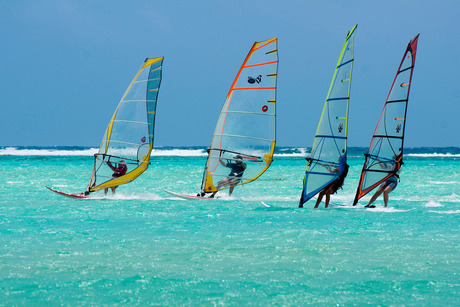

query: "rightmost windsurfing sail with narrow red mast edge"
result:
(353, 34), (419, 205)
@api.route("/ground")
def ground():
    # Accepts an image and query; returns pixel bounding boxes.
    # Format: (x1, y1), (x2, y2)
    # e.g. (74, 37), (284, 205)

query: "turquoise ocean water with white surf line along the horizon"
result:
(0, 147), (460, 306)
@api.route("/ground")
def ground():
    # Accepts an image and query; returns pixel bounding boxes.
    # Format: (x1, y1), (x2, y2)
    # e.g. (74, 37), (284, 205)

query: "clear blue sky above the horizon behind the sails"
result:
(0, 0), (460, 147)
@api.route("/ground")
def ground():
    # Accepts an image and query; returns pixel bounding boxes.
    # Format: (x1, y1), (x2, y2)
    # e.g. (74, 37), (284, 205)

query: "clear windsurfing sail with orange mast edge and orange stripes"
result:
(201, 38), (278, 193)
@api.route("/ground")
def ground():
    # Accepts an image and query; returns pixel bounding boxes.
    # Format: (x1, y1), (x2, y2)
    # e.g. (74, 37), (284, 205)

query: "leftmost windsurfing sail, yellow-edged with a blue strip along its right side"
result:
(85, 57), (163, 194)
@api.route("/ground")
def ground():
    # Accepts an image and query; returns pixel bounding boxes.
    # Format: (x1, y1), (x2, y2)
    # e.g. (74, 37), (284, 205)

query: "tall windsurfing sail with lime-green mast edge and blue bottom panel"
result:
(299, 25), (358, 207)
